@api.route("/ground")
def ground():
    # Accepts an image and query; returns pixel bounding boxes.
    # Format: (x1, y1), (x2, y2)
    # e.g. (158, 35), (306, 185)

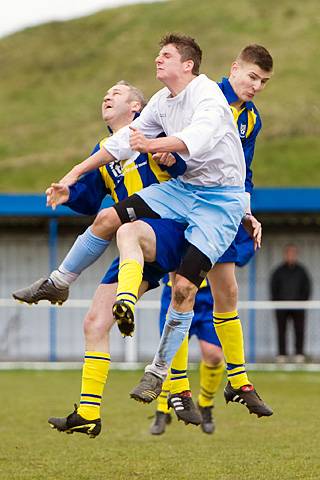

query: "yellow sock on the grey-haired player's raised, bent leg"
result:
(117, 258), (143, 311)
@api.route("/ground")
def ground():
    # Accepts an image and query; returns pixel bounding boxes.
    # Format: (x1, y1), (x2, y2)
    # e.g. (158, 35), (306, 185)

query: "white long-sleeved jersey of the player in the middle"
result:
(103, 74), (246, 187)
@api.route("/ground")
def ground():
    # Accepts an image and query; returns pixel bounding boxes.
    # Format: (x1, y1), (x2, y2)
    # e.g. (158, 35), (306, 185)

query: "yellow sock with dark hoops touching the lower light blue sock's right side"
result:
(170, 335), (190, 394)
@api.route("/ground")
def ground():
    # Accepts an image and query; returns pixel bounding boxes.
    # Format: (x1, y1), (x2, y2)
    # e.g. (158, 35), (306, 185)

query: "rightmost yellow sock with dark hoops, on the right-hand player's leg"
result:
(213, 310), (250, 388)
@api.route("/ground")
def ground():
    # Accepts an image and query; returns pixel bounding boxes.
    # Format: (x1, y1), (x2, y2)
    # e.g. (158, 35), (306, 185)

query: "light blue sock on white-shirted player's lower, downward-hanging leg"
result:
(145, 308), (193, 377)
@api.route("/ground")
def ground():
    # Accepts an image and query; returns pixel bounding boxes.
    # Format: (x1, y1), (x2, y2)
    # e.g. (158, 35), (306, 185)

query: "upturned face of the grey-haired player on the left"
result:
(101, 85), (131, 122)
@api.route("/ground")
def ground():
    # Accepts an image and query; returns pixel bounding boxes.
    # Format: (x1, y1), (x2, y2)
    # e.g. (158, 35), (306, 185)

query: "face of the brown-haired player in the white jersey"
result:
(155, 43), (187, 83)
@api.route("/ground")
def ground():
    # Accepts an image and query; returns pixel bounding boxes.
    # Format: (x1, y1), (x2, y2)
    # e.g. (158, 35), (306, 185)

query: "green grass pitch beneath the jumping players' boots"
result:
(0, 371), (320, 480)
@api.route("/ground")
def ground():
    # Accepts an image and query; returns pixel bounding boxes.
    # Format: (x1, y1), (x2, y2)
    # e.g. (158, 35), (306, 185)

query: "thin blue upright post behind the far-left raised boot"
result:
(49, 218), (58, 362)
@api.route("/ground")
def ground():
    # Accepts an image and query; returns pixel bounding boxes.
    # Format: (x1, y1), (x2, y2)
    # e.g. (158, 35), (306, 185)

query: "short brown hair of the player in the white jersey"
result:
(159, 33), (202, 75)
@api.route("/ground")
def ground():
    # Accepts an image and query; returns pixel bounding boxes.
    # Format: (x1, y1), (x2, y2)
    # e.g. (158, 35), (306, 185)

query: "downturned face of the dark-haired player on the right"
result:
(230, 61), (272, 102)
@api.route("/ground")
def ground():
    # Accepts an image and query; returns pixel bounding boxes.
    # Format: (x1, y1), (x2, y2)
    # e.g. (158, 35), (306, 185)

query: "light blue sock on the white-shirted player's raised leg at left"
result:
(59, 227), (110, 274)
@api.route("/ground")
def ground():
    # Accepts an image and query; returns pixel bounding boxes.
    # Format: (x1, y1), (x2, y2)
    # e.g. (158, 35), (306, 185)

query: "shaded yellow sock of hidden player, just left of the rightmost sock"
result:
(198, 360), (225, 407)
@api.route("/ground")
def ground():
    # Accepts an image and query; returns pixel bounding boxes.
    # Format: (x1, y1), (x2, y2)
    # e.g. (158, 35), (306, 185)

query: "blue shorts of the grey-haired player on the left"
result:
(101, 218), (188, 290)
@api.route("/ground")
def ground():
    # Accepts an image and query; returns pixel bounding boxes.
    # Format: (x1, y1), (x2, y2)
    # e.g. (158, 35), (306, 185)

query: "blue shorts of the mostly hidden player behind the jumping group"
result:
(159, 285), (221, 347)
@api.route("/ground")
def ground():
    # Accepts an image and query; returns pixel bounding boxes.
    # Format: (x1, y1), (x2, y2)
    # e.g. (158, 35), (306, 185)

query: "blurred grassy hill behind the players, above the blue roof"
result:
(0, 0), (320, 192)
